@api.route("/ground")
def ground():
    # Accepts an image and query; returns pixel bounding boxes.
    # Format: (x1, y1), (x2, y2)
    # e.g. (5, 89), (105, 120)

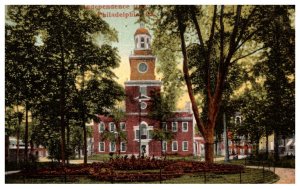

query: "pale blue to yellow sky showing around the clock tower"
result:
(96, 5), (189, 110)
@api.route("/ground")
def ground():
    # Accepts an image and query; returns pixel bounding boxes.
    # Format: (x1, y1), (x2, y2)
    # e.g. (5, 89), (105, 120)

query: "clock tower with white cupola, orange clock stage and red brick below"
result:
(125, 24), (161, 114)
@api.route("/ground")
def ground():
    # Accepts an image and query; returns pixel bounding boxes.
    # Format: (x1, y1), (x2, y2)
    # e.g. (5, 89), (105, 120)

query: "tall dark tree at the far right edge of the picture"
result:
(256, 6), (295, 160)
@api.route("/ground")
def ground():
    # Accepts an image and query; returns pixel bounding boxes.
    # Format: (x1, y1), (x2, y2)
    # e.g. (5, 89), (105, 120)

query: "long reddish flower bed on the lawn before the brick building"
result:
(13, 159), (244, 182)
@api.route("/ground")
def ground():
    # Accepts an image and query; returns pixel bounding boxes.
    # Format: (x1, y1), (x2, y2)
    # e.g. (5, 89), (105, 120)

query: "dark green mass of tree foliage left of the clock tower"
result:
(5, 5), (123, 163)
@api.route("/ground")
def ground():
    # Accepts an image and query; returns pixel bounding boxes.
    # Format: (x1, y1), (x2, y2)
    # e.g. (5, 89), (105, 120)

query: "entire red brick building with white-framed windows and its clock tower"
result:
(93, 26), (198, 156)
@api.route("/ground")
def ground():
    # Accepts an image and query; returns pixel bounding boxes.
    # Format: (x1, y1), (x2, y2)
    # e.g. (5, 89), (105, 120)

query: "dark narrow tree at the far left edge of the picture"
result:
(5, 6), (45, 162)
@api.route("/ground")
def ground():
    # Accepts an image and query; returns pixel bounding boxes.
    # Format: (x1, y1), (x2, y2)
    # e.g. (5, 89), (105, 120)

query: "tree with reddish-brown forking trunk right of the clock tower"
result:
(146, 5), (267, 162)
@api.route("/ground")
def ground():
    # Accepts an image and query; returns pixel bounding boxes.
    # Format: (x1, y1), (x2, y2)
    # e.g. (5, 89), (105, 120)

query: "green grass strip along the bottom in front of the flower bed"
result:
(5, 168), (279, 184)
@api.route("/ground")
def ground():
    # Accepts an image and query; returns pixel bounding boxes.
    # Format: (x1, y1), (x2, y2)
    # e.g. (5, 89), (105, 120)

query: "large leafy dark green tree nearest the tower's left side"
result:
(6, 5), (122, 164)
